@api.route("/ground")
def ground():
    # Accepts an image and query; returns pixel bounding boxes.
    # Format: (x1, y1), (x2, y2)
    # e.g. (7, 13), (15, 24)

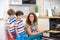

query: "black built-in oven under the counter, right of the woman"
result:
(49, 18), (60, 38)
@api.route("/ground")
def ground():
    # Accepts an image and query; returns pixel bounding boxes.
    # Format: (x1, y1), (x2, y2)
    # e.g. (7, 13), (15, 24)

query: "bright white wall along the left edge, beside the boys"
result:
(0, 0), (8, 40)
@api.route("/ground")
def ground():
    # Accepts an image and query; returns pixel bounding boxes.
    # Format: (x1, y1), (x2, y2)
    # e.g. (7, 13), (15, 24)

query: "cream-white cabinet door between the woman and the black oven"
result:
(38, 18), (49, 36)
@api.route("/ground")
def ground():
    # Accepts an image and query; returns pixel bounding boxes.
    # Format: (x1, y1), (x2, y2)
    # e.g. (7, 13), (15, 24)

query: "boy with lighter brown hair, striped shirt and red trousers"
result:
(6, 9), (16, 40)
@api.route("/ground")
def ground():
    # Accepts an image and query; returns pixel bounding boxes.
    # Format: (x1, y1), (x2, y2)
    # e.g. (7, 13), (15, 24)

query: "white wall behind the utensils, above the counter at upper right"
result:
(43, 0), (60, 15)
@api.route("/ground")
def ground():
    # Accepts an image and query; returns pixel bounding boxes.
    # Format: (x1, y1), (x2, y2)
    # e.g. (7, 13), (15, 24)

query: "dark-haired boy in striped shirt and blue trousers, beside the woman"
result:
(15, 11), (25, 40)
